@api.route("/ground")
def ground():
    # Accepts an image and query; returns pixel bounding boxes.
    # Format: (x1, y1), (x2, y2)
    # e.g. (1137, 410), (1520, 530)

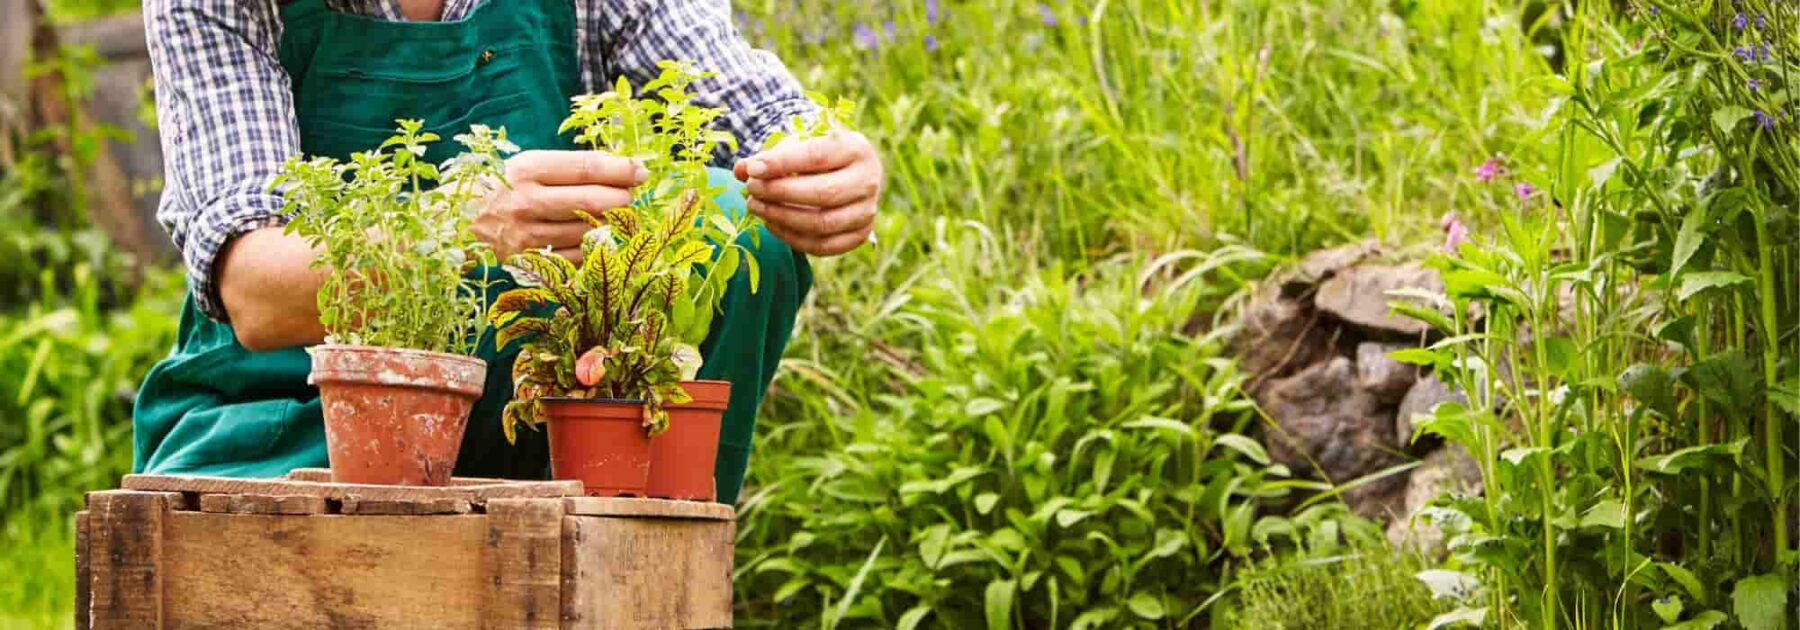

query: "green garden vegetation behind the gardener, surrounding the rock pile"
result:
(0, 0), (1800, 628)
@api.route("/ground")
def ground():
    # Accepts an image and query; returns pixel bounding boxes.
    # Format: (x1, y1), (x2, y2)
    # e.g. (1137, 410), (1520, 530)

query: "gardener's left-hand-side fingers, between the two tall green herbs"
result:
(473, 151), (650, 265)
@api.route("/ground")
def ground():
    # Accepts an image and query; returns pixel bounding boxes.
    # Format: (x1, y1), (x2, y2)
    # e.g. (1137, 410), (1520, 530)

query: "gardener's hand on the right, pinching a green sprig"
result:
(733, 131), (886, 256)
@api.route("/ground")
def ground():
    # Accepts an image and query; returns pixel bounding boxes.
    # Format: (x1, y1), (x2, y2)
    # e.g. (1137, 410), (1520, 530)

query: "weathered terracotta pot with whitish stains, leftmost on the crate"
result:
(308, 346), (488, 486)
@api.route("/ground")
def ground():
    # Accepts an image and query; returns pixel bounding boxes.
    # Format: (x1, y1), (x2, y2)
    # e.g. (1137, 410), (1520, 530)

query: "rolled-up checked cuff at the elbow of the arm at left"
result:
(182, 194), (288, 324)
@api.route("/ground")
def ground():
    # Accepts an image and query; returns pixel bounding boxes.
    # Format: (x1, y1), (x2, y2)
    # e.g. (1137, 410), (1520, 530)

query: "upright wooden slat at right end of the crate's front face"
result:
(479, 499), (563, 628)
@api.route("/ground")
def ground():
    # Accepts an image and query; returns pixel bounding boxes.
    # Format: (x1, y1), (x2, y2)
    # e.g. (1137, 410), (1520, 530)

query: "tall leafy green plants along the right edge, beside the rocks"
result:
(1397, 0), (1800, 630)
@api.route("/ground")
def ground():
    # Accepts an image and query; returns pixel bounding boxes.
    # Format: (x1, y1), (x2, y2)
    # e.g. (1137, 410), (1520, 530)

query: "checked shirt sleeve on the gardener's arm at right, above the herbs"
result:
(590, 0), (817, 162)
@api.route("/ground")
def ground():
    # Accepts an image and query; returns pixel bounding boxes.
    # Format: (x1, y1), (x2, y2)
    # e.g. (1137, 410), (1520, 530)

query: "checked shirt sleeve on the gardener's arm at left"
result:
(144, 0), (301, 320)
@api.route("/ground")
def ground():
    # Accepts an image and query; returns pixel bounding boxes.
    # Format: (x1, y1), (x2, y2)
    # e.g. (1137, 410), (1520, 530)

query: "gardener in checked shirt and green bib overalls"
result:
(133, 0), (882, 502)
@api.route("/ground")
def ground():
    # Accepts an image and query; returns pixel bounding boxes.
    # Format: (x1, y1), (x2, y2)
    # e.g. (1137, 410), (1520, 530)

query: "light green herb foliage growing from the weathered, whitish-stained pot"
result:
(274, 121), (518, 355)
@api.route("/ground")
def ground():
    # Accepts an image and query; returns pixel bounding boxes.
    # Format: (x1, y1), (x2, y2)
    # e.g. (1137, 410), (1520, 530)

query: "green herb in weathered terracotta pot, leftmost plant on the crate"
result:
(275, 121), (518, 486)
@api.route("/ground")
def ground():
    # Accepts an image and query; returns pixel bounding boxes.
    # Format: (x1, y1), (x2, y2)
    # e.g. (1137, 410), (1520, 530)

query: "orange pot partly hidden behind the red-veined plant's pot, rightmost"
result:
(650, 380), (731, 500)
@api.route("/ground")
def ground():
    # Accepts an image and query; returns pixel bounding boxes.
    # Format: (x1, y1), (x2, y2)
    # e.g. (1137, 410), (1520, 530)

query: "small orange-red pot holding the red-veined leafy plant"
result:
(544, 398), (666, 497)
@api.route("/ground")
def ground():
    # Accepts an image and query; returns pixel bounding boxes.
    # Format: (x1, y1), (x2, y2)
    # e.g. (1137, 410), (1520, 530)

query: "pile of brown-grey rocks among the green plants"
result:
(1233, 241), (1480, 547)
